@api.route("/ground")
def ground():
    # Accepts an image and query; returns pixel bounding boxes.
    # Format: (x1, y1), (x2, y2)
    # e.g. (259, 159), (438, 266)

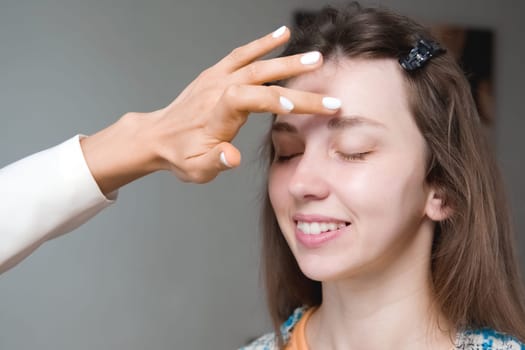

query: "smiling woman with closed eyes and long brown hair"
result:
(246, 3), (525, 350)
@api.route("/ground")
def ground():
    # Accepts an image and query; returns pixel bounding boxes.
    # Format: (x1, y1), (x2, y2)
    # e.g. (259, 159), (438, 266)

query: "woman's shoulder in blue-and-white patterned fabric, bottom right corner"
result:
(456, 328), (525, 350)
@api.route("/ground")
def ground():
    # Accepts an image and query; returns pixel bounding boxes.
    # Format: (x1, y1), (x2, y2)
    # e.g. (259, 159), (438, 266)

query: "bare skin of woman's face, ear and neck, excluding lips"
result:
(268, 58), (452, 349)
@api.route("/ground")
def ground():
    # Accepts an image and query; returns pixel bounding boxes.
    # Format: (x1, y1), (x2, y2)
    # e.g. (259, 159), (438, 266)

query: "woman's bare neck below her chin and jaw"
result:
(306, 245), (455, 350)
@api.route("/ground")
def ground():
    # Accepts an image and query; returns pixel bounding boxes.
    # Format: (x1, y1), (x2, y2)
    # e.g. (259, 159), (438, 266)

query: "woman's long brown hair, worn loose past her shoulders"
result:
(261, 2), (525, 344)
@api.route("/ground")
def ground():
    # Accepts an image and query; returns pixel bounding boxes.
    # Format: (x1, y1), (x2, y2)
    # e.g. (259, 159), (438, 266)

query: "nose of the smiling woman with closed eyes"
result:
(288, 152), (329, 201)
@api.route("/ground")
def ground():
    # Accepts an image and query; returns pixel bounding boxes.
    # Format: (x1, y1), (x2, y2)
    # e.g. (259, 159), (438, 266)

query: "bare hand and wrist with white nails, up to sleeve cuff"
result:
(81, 27), (338, 193)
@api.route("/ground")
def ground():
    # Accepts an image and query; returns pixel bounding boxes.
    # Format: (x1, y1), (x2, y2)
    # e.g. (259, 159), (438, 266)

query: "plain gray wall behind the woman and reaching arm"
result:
(0, 0), (525, 350)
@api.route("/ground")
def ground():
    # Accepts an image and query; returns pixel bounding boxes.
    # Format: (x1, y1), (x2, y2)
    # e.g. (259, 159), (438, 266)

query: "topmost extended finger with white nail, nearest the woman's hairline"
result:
(215, 26), (290, 72)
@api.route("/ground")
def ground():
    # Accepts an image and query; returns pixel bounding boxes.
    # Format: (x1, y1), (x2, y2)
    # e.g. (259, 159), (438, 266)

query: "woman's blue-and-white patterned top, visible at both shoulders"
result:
(239, 307), (525, 350)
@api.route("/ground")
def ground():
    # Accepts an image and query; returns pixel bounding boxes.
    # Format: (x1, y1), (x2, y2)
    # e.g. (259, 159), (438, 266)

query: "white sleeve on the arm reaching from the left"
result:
(0, 135), (117, 272)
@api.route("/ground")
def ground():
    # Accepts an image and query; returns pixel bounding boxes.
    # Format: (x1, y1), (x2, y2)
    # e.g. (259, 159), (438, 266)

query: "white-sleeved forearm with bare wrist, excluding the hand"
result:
(0, 112), (160, 272)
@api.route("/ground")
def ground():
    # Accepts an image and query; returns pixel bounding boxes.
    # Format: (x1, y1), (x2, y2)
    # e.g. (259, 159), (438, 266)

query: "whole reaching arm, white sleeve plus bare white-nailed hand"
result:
(0, 27), (339, 272)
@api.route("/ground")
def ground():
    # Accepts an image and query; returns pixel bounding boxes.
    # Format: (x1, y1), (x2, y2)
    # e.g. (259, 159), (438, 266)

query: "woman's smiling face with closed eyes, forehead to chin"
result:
(269, 59), (433, 281)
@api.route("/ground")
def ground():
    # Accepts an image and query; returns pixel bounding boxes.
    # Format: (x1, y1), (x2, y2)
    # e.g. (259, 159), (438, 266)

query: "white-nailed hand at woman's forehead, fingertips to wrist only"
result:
(149, 27), (342, 183)
